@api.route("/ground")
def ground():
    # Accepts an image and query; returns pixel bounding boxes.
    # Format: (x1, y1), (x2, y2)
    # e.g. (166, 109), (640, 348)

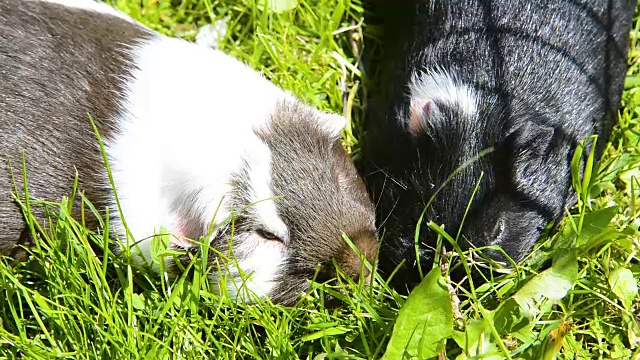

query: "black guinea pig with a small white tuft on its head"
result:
(358, 0), (635, 288)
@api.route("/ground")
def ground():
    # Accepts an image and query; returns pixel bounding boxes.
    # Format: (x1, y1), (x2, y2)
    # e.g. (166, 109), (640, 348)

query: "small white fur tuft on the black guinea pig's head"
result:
(410, 70), (478, 122)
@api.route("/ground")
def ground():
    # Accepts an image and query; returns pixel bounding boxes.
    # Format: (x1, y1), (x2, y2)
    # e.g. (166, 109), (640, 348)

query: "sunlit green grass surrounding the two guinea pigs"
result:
(0, 0), (640, 359)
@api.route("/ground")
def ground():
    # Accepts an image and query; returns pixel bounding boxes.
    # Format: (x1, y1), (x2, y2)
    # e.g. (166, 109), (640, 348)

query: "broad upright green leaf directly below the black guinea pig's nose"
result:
(383, 268), (453, 360)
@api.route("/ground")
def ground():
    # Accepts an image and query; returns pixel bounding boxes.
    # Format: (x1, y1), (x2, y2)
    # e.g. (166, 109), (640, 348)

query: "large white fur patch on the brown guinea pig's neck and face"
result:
(105, 35), (292, 295)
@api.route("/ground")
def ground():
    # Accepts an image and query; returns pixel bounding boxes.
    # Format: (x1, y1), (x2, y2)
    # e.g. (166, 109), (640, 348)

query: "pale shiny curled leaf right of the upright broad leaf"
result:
(513, 251), (578, 317)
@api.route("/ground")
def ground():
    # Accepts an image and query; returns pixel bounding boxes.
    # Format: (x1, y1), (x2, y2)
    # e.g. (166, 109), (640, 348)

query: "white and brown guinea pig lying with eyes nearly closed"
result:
(0, 0), (377, 304)
